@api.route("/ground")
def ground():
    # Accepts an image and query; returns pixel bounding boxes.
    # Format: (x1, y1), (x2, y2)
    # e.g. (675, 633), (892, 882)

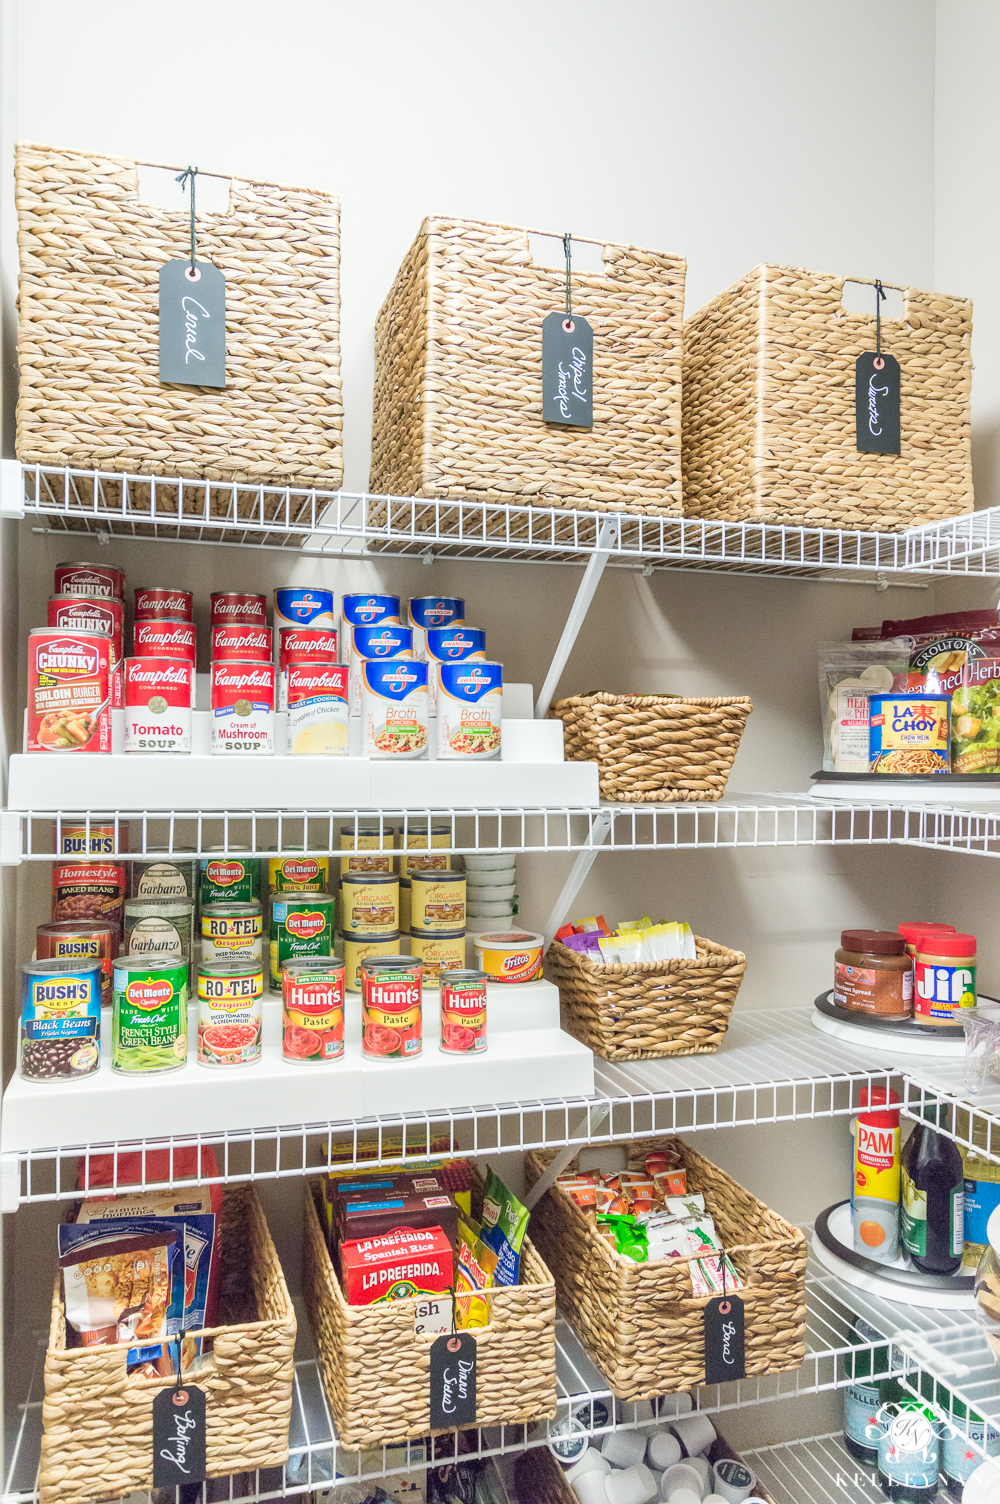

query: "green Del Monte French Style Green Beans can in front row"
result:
(111, 955), (188, 1075)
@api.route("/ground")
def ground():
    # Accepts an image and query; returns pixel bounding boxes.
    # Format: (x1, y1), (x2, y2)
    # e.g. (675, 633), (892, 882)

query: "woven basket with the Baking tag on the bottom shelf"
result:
(39, 1185), (295, 1504)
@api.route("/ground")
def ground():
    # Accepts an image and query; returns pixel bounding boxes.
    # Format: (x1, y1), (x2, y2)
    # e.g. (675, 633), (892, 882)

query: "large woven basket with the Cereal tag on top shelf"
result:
(17, 141), (343, 502)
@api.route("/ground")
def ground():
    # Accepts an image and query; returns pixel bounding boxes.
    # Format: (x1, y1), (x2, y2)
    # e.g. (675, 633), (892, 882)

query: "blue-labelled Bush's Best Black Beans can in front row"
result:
(20, 957), (101, 1081)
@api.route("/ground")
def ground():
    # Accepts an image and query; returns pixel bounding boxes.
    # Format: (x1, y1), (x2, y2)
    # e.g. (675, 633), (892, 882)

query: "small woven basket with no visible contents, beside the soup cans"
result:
(549, 692), (753, 805)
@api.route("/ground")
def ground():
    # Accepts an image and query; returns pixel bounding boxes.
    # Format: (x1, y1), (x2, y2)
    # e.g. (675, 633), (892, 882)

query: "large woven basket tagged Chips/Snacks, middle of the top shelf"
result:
(370, 217), (686, 525)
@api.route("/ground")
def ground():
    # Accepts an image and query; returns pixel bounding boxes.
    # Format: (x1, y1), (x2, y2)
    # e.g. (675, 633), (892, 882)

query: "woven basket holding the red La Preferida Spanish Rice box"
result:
(302, 1187), (556, 1450)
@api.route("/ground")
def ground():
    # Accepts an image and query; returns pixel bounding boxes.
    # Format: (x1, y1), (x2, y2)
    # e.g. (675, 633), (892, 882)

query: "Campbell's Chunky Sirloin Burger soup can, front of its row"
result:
(27, 627), (111, 752)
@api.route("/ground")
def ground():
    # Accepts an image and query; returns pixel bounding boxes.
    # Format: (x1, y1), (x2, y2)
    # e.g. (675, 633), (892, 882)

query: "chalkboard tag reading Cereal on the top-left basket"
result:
(159, 260), (226, 387)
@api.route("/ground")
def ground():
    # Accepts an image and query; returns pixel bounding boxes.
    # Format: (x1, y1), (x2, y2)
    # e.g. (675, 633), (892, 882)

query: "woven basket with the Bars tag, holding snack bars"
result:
(525, 1139), (806, 1400)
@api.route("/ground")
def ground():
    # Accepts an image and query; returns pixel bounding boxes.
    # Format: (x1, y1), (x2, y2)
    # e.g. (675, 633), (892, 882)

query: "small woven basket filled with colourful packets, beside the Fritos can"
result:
(546, 935), (746, 1060)
